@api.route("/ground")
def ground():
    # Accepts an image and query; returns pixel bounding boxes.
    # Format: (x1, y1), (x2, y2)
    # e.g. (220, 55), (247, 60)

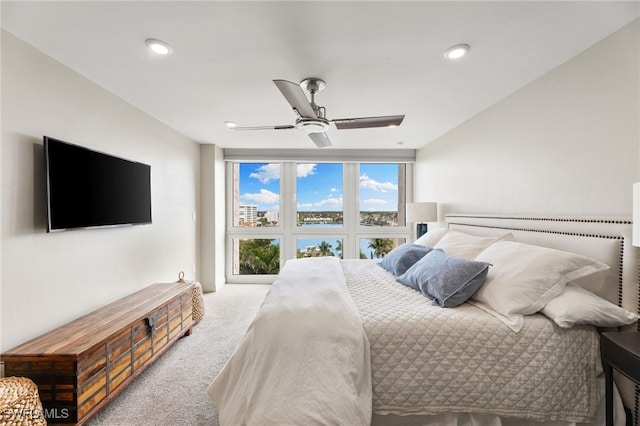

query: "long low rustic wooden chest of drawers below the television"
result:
(2, 283), (194, 424)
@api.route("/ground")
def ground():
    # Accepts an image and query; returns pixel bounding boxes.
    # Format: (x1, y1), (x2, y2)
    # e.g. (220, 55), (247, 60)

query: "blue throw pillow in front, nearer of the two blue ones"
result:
(396, 249), (490, 308)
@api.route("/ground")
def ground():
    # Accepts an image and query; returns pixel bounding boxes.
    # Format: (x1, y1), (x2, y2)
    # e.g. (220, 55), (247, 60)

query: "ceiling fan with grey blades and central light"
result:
(231, 78), (404, 148)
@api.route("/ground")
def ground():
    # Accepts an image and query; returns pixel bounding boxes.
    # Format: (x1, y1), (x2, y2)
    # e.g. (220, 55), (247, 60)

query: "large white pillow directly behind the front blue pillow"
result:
(472, 241), (609, 332)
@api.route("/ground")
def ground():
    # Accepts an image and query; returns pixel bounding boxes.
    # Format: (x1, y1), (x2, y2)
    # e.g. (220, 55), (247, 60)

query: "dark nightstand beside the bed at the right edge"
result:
(600, 333), (640, 426)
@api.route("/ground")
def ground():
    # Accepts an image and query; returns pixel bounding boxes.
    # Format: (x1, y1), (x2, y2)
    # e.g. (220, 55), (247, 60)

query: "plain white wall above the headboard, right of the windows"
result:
(415, 20), (640, 221)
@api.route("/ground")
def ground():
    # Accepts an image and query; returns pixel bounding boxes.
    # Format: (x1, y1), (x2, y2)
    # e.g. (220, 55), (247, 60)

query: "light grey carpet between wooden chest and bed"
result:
(88, 284), (270, 426)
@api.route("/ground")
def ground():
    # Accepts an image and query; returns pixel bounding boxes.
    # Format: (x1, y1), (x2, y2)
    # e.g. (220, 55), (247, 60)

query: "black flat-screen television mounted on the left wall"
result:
(44, 136), (151, 232)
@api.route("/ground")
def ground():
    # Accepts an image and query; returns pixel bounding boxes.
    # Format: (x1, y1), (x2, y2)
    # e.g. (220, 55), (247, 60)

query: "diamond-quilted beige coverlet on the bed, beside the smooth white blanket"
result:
(341, 260), (601, 422)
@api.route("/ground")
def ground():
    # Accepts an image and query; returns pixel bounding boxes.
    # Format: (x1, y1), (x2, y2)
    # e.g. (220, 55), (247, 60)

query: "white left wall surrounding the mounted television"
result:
(0, 32), (200, 350)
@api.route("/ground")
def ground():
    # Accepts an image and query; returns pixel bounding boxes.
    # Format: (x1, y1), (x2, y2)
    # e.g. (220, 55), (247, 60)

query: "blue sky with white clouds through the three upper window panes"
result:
(239, 163), (398, 211)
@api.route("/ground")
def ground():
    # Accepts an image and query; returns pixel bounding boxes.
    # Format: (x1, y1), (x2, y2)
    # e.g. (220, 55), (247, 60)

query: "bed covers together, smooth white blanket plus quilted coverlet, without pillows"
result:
(209, 257), (600, 426)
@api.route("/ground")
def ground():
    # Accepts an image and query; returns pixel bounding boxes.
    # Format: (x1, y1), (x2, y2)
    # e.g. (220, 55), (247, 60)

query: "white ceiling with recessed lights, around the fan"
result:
(1, 1), (640, 149)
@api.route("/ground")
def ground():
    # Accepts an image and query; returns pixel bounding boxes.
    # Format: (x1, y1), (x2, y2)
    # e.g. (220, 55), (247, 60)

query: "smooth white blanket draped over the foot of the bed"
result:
(208, 257), (372, 426)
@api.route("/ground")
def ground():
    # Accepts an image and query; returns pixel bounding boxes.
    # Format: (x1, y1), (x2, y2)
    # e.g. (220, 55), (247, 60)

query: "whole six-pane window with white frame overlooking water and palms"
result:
(227, 161), (412, 282)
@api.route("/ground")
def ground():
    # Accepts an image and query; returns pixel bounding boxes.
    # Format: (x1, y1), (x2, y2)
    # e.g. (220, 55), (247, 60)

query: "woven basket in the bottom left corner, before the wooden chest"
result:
(0, 377), (47, 426)
